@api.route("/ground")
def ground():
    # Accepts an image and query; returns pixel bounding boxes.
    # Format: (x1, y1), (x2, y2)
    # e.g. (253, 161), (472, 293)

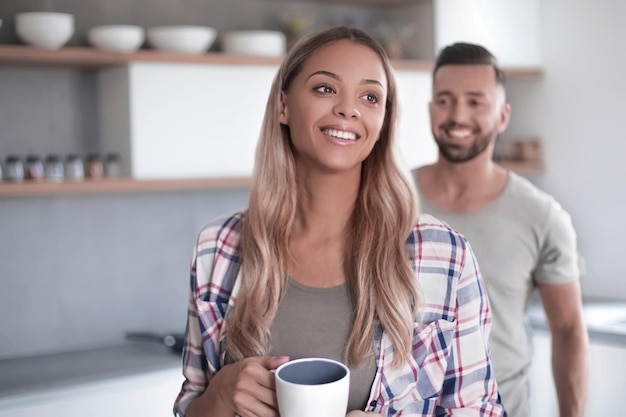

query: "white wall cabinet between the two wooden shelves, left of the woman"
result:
(100, 63), (277, 179)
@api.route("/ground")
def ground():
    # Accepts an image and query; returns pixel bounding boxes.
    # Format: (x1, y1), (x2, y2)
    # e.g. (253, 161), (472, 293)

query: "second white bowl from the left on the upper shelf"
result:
(87, 25), (145, 53)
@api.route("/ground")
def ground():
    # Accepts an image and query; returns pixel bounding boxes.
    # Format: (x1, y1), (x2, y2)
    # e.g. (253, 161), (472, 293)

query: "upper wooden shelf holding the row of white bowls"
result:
(0, 45), (541, 78)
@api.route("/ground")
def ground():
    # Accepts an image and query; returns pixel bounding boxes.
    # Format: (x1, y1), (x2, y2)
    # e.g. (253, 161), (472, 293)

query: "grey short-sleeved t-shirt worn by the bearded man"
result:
(420, 173), (579, 417)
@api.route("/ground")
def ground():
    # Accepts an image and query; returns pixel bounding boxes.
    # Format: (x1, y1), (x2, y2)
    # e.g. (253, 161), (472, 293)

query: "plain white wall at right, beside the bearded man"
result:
(507, 0), (626, 299)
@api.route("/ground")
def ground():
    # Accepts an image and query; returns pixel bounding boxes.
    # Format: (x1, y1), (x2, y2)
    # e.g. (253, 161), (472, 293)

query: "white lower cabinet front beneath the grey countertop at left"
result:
(0, 369), (182, 417)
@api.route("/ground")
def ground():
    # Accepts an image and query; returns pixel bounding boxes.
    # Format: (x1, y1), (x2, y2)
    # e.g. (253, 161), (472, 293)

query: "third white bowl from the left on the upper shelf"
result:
(147, 25), (217, 54)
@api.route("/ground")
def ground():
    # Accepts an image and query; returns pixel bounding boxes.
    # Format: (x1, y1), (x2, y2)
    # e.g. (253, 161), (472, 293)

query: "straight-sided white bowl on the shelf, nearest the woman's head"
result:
(222, 30), (287, 57)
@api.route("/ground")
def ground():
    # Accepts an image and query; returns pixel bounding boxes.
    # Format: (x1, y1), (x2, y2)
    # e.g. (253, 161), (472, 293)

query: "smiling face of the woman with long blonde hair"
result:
(279, 40), (387, 176)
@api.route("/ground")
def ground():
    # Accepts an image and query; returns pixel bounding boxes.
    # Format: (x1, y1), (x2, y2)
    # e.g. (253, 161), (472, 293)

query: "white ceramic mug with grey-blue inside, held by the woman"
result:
(275, 358), (350, 417)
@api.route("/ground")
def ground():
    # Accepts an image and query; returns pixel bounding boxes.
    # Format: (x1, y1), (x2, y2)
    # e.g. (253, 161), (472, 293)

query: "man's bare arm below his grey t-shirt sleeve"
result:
(538, 281), (589, 417)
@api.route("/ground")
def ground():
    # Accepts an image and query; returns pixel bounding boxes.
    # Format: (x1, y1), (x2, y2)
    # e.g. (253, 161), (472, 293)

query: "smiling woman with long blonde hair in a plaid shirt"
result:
(174, 27), (504, 417)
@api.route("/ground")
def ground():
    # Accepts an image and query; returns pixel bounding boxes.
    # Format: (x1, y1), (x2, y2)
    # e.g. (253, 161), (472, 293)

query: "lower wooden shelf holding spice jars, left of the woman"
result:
(0, 177), (251, 198)
